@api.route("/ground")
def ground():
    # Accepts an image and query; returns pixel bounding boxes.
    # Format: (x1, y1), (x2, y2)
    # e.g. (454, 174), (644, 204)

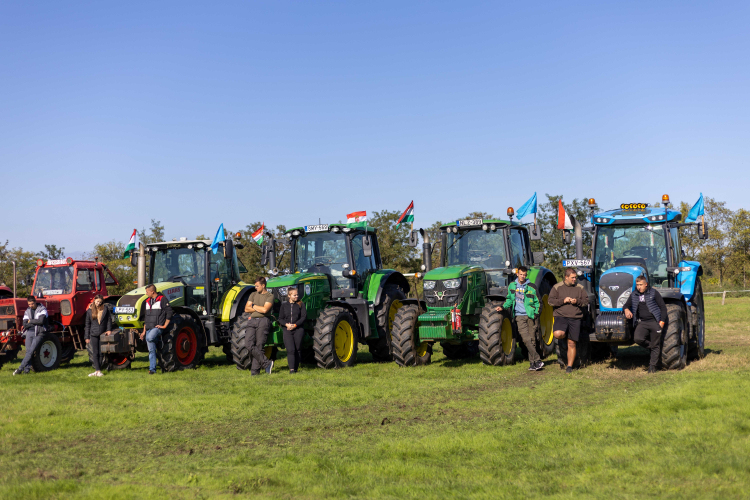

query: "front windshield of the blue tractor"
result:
(594, 225), (669, 287)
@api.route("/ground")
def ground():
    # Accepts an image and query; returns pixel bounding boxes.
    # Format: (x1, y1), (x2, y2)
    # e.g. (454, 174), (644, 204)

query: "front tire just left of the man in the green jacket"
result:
(479, 301), (516, 366)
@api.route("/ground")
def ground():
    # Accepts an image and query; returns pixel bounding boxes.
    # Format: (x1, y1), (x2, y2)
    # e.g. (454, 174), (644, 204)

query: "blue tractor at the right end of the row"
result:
(558, 195), (708, 370)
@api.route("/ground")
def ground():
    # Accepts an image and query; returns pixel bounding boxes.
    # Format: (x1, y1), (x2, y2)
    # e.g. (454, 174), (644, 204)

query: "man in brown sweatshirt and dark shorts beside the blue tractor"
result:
(549, 267), (589, 373)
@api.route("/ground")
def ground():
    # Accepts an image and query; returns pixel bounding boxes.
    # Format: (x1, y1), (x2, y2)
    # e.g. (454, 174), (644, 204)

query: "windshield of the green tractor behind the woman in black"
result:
(292, 233), (349, 288)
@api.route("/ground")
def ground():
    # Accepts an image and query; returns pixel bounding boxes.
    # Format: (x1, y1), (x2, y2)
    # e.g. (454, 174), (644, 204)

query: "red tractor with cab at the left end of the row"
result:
(0, 257), (119, 372)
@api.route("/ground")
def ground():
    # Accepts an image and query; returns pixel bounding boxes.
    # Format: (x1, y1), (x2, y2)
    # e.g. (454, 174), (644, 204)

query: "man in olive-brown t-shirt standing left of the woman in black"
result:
(245, 276), (273, 375)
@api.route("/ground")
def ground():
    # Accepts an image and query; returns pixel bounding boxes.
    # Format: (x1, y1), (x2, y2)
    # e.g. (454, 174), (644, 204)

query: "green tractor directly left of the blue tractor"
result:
(392, 213), (557, 366)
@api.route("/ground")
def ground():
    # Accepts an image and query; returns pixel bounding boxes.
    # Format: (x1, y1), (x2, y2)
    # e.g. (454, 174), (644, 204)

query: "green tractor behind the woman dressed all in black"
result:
(232, 222), (410, 369)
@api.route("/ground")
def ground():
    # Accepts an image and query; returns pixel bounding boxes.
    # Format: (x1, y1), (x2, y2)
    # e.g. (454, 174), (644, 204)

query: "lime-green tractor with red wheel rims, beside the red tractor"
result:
(107, 233), (254, 372)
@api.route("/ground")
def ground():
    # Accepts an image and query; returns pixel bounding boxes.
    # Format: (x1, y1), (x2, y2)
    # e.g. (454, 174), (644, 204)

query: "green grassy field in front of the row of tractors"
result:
(0, 299), (750, 499)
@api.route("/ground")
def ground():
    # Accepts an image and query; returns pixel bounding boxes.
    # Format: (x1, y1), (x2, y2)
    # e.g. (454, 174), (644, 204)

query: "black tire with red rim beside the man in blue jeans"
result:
(158, 314), (206, 372)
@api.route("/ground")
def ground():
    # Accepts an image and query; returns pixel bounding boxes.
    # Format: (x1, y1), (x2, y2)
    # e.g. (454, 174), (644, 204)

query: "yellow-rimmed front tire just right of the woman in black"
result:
(313, 307), (358, 369)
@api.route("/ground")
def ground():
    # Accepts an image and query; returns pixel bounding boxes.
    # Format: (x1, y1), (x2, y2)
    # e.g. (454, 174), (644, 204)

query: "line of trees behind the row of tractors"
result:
(0, 194), (750, 296)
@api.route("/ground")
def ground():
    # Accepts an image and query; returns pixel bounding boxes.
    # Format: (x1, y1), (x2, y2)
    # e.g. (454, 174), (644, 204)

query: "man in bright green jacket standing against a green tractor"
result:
(497, 266), (544, 371)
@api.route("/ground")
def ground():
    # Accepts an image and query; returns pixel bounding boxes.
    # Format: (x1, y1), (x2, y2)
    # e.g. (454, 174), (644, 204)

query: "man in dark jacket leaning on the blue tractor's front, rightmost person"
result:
(623, 276), (668, 373)
